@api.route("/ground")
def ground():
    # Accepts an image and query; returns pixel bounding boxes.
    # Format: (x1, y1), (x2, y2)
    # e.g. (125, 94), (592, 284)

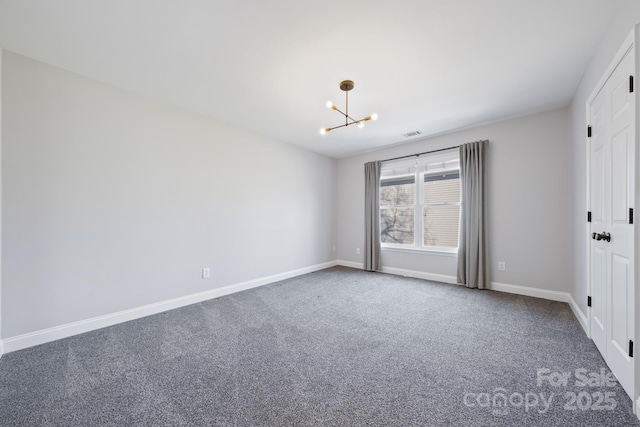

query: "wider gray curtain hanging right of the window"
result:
(458, 141), (491, 289)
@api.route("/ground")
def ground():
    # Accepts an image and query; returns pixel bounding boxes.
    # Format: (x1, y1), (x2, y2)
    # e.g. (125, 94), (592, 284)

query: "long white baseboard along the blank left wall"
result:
(0, 261), (337, 355)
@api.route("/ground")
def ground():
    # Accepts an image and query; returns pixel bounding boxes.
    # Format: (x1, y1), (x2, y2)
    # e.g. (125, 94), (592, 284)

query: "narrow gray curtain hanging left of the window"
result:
(364, 162), (380, 271)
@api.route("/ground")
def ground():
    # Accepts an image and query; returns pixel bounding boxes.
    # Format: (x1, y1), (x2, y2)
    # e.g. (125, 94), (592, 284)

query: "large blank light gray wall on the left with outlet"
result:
(1, 51), (336, 338)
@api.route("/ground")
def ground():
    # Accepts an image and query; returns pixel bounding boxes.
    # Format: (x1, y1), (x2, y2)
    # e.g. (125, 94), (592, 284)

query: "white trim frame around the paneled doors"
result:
(584, 24), (640, 412)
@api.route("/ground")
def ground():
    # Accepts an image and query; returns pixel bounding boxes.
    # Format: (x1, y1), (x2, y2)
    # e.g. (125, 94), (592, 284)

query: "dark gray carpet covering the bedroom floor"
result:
(0, 267), (640, 426)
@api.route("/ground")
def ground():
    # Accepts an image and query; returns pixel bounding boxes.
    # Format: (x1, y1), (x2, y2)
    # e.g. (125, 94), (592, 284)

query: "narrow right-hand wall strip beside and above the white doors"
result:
(570, 0), (640, 314)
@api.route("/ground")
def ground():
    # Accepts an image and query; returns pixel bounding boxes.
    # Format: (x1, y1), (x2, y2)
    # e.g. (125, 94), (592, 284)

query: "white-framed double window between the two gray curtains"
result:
(380, 151), (460, 252)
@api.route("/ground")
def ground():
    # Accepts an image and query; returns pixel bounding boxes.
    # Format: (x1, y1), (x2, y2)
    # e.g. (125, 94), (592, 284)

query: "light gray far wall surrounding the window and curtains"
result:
(338, 109), (571, 292)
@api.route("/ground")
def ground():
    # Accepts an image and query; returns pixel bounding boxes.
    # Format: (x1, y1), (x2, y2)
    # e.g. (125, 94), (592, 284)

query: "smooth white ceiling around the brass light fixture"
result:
(0, 0), (620, 158)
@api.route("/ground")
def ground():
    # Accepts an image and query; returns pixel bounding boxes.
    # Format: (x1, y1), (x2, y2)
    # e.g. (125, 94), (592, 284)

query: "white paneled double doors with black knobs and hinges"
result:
(589, 50), (636, 398)
